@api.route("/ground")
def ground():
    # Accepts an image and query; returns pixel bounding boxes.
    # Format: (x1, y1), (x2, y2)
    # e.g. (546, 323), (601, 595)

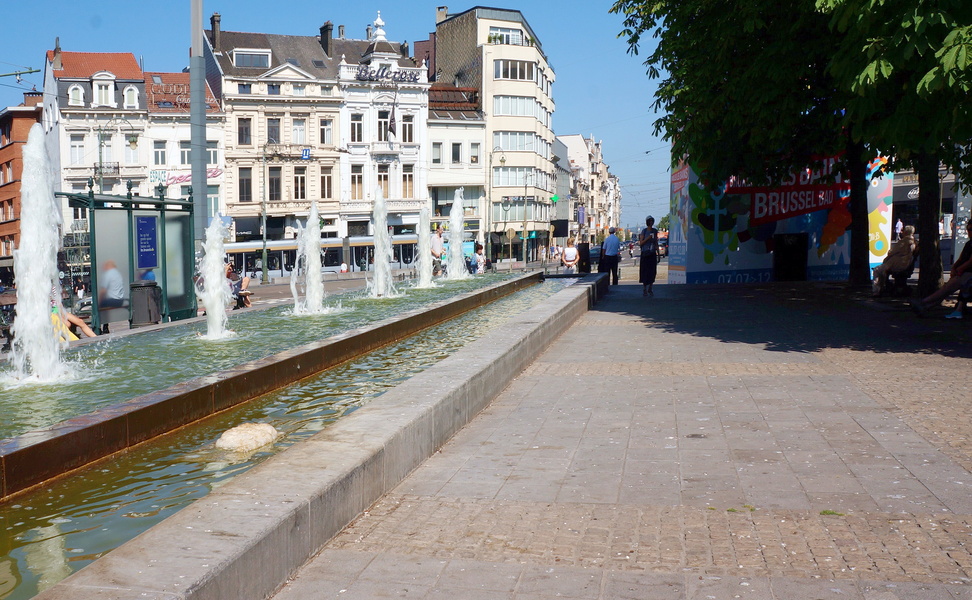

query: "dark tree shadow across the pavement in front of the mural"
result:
(594, 282), (972, 358)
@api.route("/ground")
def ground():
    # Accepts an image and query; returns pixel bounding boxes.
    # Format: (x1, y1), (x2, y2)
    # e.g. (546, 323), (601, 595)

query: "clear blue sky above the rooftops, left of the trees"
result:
(0, 0), (669, 226)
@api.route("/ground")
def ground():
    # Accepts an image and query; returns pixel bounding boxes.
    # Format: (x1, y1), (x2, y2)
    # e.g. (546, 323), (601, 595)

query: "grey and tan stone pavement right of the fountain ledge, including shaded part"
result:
(275, 269), (972, 600)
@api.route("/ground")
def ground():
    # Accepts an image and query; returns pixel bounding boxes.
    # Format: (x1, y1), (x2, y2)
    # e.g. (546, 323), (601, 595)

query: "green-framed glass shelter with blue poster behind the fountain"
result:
(55, 180), (196, 331)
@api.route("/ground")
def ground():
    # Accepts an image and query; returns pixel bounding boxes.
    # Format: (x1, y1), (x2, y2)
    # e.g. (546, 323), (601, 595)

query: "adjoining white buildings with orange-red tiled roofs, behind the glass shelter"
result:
(43, 45), (222, 234)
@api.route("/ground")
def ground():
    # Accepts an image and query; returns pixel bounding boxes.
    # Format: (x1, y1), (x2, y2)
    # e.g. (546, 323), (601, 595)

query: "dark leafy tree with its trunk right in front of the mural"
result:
(611, 0), (870, 283)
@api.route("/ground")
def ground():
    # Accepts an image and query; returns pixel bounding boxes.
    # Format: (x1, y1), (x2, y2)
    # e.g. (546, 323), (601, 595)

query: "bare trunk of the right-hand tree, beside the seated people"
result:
(915, 153), (942, 298)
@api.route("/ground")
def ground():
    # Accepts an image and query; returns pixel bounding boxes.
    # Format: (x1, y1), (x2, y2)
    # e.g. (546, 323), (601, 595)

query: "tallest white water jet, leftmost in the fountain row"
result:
(11, 124), (67, 382)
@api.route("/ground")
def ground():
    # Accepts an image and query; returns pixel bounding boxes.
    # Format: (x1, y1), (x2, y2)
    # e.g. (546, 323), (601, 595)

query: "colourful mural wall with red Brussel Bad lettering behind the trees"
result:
(668, 159), (891, 283)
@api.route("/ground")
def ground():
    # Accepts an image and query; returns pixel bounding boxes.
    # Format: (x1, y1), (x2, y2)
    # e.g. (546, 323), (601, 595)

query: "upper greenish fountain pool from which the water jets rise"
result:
(0, 274), (510, 438)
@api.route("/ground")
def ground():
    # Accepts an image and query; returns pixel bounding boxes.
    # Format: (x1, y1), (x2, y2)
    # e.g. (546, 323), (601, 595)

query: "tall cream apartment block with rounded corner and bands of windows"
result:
(430, 7), (556, 260)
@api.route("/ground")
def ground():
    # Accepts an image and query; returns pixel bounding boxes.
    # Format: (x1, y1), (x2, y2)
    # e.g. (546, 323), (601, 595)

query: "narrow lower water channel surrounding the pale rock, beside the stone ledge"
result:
(0, 280), (573, 600)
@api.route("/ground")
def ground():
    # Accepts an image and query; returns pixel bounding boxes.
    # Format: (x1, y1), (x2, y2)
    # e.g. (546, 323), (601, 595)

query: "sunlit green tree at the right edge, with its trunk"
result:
(818, 0), (972, 296)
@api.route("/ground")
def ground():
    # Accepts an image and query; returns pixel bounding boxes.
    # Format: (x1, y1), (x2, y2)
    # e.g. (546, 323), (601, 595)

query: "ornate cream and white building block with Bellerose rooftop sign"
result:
(206, 14), (429, 241)
